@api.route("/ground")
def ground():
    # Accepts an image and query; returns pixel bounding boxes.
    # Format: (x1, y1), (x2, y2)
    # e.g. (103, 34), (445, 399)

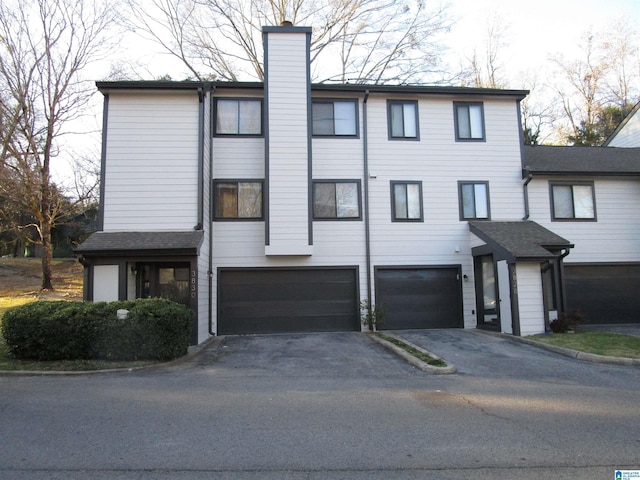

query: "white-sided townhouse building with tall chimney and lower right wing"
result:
(77, 26), (640, 344)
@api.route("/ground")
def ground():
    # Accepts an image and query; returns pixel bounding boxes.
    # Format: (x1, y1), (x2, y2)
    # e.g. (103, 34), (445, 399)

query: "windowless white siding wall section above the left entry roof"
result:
(104, 92), (199, 231)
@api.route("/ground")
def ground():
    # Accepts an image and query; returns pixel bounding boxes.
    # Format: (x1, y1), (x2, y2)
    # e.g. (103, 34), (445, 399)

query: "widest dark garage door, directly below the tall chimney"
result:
(218, 268), (360, 335)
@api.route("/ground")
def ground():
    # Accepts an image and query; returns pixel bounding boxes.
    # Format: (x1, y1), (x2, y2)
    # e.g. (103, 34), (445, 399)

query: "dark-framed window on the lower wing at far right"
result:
(551, 182), (596, 220)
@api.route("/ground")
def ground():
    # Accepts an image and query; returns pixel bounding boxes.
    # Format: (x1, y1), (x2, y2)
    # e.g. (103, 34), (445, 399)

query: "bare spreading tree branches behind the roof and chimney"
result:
(120, 0), (450, 83)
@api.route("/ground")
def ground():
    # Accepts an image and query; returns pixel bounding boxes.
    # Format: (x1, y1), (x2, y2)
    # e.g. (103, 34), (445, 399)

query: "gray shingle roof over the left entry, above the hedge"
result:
(75, 230), (204, 256)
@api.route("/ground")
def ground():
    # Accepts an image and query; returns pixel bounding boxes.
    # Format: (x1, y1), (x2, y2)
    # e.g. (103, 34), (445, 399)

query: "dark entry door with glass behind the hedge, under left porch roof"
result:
(137, 263), (190, 306)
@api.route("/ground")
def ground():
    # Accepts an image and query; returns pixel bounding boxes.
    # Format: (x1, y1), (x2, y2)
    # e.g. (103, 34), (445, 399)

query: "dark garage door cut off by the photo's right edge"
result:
(564, 264), (640, 325)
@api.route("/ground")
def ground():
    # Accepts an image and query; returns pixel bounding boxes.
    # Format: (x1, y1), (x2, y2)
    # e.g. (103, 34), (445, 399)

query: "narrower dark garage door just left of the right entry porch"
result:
(375, 267), (464, 330)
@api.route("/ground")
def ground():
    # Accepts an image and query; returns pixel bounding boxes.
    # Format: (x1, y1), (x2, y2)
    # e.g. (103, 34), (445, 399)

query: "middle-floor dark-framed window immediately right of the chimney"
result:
(313, 180), (361, 220)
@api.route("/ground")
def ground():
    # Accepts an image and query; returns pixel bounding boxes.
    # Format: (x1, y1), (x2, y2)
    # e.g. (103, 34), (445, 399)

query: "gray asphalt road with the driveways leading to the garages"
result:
(0, 330), (640, 480)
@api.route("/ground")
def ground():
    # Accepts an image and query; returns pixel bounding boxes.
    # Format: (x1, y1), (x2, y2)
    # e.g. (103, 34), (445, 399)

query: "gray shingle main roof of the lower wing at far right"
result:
(524, 145), (640, 176)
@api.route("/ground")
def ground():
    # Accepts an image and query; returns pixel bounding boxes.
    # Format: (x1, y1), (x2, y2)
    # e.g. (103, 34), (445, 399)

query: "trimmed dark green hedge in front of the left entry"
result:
(2, 298), (193, 360)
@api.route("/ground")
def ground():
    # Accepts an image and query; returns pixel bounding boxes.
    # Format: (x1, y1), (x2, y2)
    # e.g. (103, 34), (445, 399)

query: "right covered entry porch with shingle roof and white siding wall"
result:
(469, 221), (573, 336)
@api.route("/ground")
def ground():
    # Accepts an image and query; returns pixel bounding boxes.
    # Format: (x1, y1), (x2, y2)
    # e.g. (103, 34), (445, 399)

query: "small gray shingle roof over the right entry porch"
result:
(469, 220), (573, 260)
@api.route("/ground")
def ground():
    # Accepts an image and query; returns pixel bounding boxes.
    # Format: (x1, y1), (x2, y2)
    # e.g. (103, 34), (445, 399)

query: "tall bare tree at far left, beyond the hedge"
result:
(0, 0), (116, 289)
